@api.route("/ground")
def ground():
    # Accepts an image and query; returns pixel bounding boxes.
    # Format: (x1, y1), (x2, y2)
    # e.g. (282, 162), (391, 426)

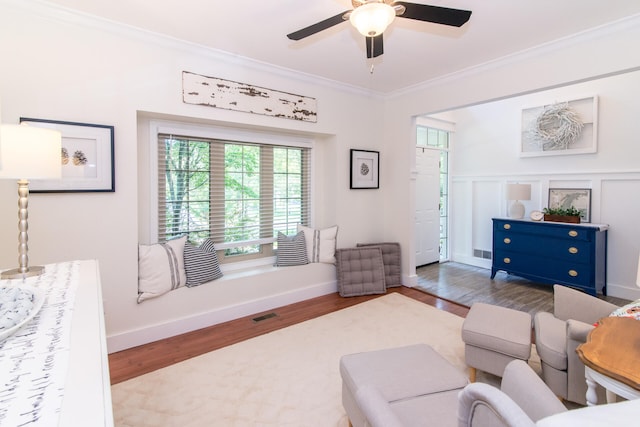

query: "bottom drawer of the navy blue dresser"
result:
(493, 251), (593, 287)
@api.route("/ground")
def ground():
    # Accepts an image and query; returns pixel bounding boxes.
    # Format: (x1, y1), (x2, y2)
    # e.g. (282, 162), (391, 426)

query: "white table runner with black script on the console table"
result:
(0, 262), (79, 426)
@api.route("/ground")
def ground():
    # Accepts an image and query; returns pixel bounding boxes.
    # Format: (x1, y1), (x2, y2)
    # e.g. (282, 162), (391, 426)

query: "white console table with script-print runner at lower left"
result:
(0, 260), (113, 427)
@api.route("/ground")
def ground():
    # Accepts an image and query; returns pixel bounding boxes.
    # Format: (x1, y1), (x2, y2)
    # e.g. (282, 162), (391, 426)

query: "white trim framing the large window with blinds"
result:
(148, 120), (315, 264)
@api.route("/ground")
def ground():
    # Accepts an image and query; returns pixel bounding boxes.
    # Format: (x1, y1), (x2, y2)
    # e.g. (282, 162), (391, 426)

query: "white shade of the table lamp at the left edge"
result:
(0, 125), (62, 180)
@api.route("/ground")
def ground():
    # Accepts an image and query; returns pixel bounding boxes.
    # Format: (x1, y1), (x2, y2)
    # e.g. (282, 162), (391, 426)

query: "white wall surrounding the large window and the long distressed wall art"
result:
(0, 0), (384, 348)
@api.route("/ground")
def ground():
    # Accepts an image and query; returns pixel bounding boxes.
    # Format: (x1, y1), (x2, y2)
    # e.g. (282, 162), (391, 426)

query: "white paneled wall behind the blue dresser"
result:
(447, 71), (640, 299)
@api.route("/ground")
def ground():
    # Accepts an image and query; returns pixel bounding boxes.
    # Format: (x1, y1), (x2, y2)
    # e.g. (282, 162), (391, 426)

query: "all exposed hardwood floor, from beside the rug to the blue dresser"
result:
(109, 263), (626, 384)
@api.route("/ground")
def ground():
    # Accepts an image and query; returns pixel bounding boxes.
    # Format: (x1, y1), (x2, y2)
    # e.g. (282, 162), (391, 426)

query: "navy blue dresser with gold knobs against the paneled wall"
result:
(491, 218), (608, 295)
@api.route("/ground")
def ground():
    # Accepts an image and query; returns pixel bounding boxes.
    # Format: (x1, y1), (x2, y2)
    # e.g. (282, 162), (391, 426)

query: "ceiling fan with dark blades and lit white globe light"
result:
(287, 0), (471, 58)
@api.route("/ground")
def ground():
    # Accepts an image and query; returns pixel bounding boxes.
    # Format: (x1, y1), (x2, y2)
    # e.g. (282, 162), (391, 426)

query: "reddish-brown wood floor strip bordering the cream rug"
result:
(109, 286), (469, 384)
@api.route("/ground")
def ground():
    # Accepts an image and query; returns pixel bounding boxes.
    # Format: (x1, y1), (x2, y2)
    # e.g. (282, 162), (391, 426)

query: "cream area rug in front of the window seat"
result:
(112, 293), (536, 427)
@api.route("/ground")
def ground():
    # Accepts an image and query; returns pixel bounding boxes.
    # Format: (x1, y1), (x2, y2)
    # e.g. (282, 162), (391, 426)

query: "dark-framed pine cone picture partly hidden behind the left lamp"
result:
(20, 117), (115, 193)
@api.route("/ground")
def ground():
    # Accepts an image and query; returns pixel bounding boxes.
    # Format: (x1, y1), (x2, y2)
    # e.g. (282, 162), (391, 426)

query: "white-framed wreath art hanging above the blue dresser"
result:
(520, 96), (598, 157)
